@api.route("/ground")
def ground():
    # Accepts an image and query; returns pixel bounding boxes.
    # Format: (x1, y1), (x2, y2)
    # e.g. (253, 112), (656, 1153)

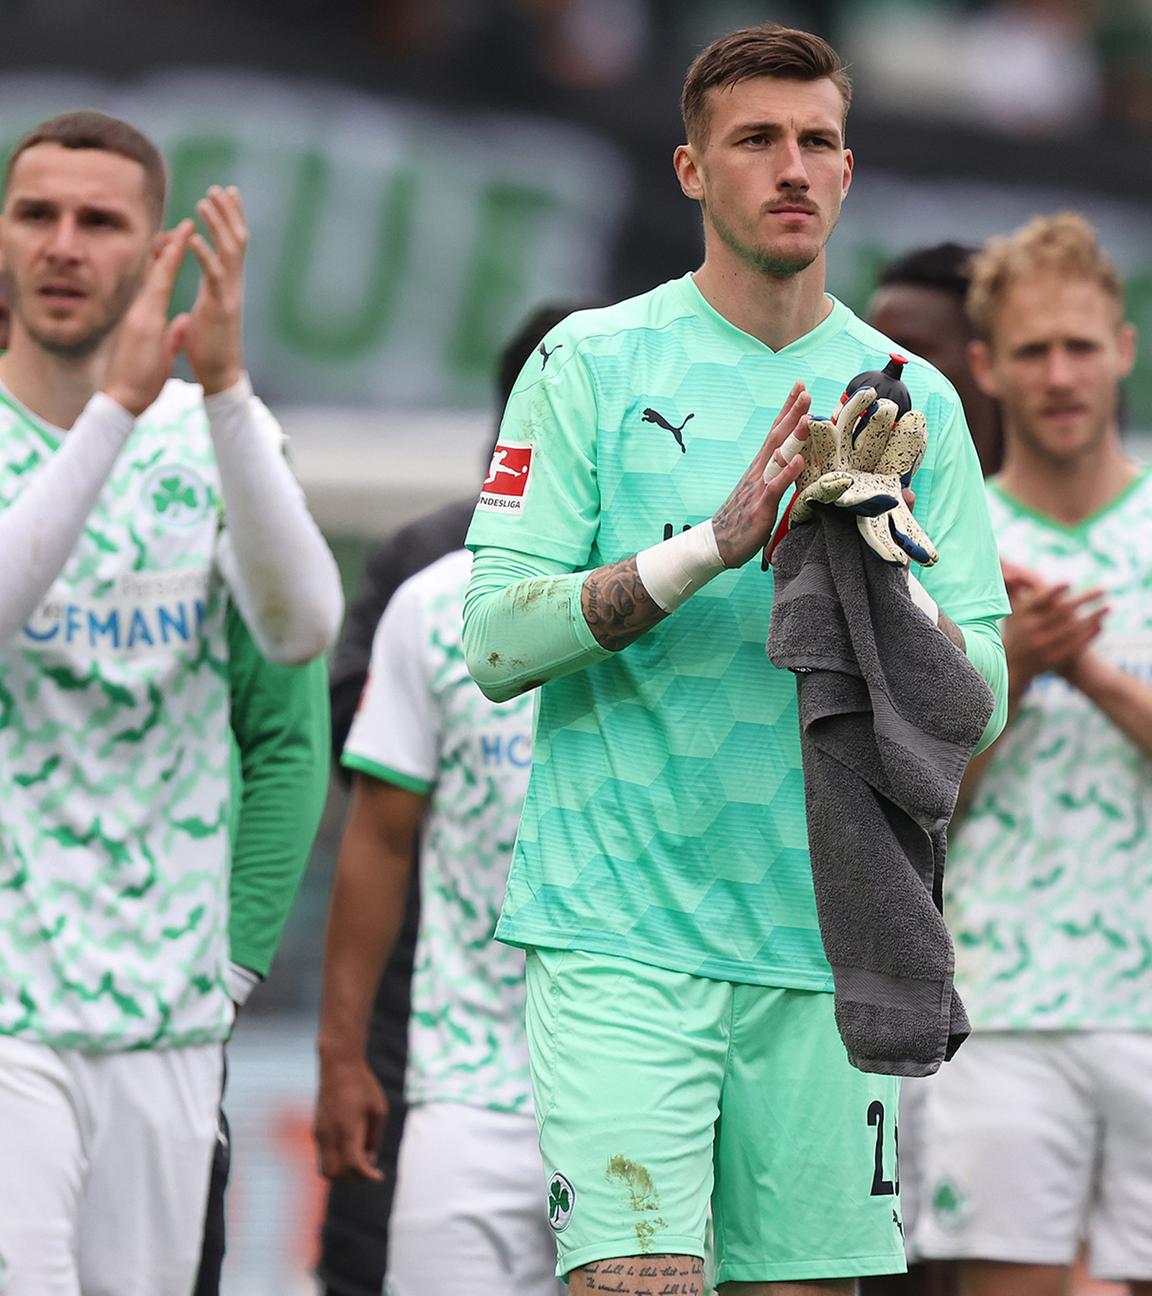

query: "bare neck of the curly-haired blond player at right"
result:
(998, 435), (1136, 526)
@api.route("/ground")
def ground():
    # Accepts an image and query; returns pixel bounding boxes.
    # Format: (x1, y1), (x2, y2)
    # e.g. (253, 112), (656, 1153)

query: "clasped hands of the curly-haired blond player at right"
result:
(1003, 573), (1108, 693)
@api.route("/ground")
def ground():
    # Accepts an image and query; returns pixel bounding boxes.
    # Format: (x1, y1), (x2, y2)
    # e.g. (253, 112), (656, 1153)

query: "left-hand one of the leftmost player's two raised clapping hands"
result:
(101, 220), (192, 419)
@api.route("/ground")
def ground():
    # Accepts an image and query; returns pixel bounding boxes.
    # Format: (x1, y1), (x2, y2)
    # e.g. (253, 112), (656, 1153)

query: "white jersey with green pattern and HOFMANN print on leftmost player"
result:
(0, 381), (232, 1051)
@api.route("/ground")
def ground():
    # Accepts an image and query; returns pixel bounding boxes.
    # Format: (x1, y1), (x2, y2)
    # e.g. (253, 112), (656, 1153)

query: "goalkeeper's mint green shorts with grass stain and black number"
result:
(527, 949), (904, 1283)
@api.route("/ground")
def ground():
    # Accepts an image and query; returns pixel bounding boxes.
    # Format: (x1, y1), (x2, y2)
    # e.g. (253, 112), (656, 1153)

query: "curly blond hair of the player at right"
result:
(967, 211), (1123, 342)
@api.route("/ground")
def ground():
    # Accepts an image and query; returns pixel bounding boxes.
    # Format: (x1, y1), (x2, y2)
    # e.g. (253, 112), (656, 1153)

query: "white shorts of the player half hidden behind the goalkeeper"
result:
(384, 1103), (565, 1296)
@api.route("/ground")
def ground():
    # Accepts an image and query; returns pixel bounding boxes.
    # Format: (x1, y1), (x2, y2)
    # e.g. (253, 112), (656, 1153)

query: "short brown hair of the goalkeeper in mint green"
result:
(680, 22), (851, 144)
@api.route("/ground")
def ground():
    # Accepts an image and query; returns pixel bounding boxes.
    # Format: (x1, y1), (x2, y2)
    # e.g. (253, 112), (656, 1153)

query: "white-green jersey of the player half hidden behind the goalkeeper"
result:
(343, 550), (533, 1112)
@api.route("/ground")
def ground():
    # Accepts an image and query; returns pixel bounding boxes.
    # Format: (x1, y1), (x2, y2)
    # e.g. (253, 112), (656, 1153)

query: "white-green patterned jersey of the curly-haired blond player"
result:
(945, 469), (1152, 1030)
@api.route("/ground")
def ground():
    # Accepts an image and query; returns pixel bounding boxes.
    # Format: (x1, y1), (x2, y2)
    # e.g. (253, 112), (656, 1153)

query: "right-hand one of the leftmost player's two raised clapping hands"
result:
(184, 185), (248, 397)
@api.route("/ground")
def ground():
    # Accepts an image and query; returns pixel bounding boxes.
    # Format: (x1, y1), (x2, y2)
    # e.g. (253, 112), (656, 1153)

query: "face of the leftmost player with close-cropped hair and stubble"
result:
(0, 144), (154, 358)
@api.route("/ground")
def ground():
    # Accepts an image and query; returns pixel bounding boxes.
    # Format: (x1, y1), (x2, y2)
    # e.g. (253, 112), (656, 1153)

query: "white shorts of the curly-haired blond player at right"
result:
(914, 1032), (1152, 1282)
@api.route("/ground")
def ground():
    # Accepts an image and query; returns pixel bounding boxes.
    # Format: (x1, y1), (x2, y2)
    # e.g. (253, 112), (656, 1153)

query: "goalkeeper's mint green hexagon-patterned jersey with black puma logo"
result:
(468, 275), (1007, 990)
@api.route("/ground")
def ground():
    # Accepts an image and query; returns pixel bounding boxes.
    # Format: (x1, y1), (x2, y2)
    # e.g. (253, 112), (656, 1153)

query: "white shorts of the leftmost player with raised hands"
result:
(0, 1038), (224, 1296)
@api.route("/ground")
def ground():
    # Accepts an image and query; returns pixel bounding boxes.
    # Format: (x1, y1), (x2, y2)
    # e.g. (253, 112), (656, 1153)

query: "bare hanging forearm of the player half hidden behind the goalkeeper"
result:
(317, 826), (411, 1061)
